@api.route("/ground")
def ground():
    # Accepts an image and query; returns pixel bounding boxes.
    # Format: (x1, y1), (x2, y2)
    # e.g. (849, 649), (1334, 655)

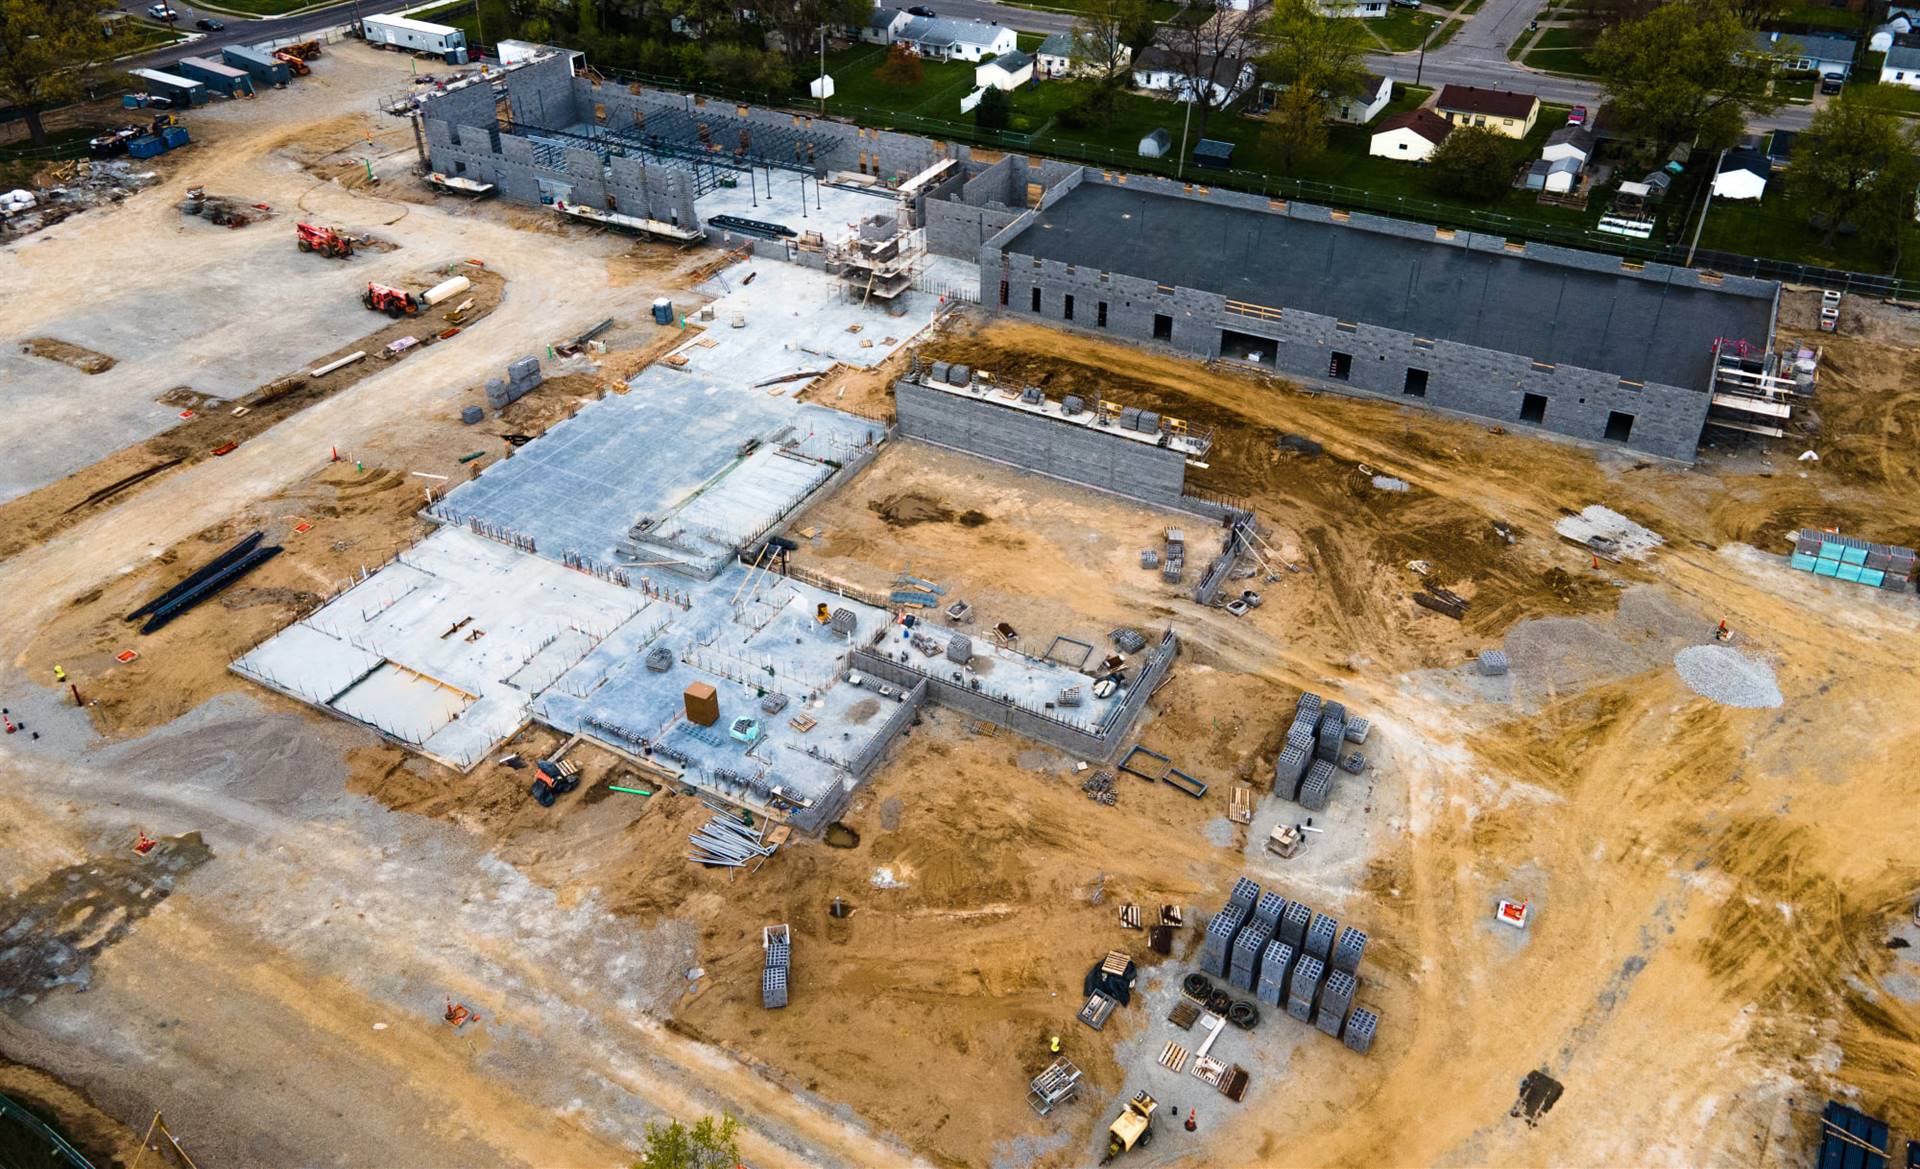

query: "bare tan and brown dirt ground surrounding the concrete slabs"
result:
(0, 50), (1920, 1169)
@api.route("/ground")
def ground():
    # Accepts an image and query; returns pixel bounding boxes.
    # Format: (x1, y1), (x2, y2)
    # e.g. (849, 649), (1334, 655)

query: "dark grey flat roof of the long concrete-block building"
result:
(1006, 179), (1772, 390)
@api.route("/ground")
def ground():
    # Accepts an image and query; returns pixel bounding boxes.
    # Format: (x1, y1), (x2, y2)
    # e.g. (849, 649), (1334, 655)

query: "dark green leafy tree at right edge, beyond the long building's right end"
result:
(1786, 94), (1914, 246)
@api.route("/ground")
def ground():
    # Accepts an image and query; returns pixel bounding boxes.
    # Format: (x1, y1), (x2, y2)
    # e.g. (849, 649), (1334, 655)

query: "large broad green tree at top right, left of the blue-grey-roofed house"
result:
(1588, 0), (1778, 150)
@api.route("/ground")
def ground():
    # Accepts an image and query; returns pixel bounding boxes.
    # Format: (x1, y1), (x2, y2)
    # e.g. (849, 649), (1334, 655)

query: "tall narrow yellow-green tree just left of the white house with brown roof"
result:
(1260, 0), (1367, 171)
